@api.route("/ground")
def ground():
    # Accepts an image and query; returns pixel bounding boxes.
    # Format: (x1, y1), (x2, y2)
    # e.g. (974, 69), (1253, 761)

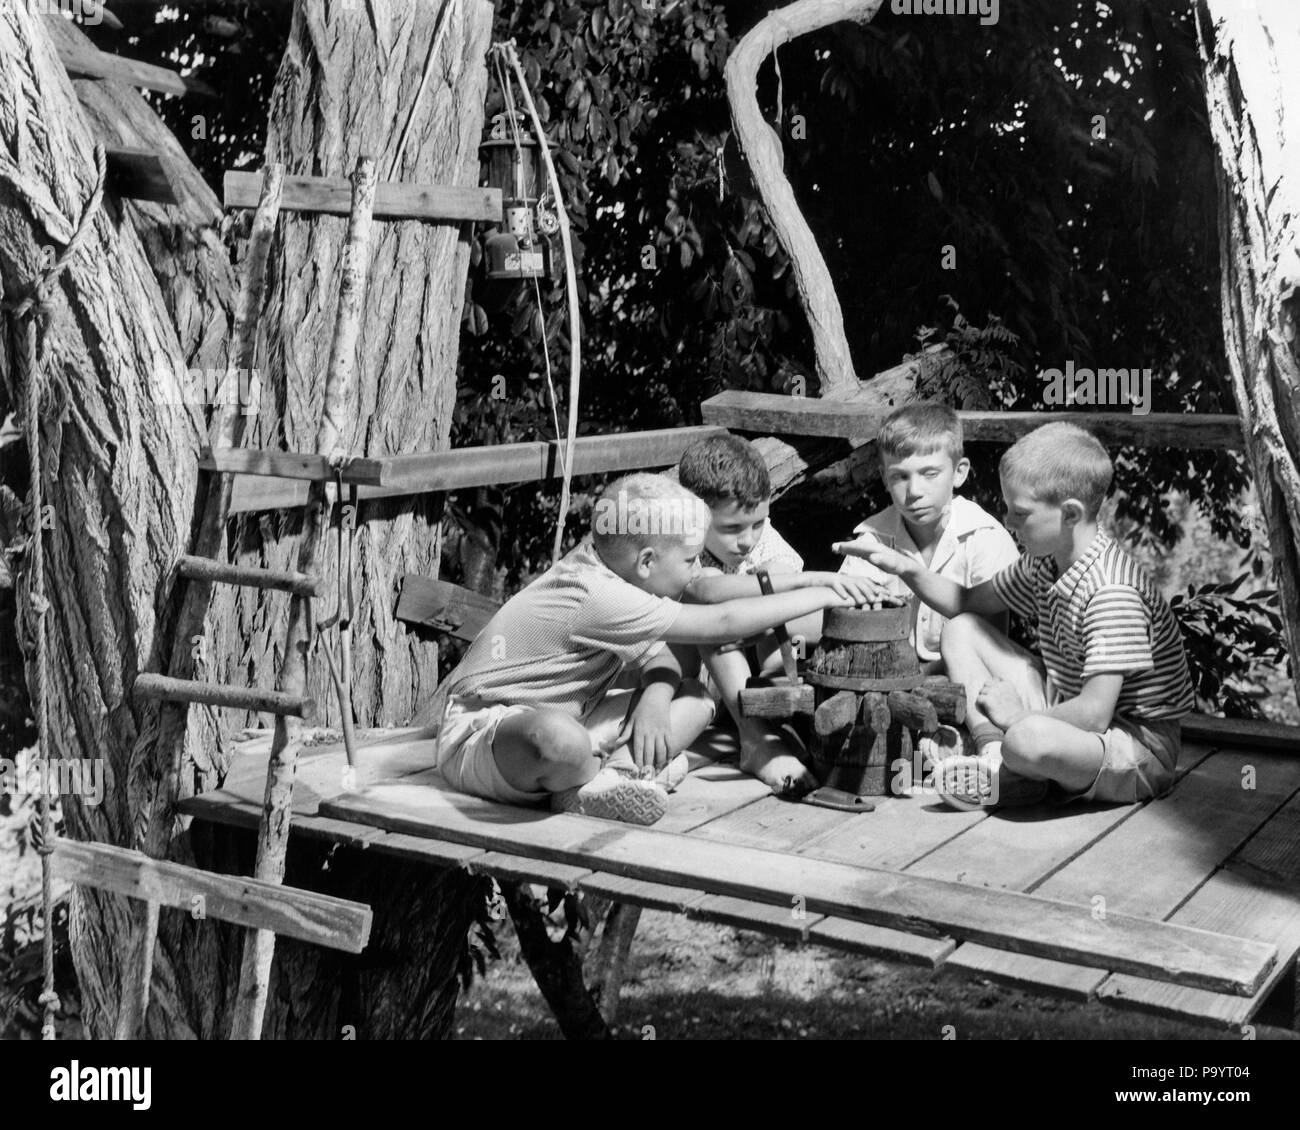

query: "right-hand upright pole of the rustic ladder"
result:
(231, 157), (376, 1040)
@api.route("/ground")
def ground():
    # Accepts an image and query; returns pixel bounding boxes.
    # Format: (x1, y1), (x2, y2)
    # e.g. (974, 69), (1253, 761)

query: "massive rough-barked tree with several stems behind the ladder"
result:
(0, 0), (491, 1038)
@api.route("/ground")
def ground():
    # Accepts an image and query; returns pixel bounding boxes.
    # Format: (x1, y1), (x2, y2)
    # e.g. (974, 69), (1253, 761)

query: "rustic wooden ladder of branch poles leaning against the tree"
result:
(55, 157), (423, 1039)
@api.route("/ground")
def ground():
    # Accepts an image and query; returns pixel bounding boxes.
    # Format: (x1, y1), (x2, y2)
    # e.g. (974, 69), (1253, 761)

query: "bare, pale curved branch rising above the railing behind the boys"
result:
(727, 0), (884, 397)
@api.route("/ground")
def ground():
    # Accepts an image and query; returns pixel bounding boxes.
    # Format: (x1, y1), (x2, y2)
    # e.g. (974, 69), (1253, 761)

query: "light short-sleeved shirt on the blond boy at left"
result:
(436, 537), (681, 719)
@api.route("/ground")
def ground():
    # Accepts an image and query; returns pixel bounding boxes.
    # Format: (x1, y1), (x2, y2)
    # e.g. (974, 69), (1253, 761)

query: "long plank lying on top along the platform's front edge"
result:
(321, 774), (1275, 993)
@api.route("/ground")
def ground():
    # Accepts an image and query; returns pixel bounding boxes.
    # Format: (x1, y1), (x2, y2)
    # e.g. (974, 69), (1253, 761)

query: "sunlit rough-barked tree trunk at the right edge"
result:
(1196, 0), (1300, 700)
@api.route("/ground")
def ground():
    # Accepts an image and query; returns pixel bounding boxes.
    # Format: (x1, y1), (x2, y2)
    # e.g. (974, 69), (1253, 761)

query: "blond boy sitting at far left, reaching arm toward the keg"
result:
(429, 475), (873, 824)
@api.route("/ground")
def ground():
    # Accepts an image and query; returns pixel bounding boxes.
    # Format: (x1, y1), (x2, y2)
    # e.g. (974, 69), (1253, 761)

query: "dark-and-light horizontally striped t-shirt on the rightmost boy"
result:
(991, 531), (1196, 720)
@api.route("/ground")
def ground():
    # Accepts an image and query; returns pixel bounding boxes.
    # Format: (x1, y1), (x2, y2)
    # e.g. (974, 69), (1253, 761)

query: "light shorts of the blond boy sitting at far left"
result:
(437, 689), (660, 805)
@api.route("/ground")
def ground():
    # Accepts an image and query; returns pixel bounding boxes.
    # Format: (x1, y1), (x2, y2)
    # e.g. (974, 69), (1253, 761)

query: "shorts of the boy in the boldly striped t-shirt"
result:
(1017, 651), (1182, 805)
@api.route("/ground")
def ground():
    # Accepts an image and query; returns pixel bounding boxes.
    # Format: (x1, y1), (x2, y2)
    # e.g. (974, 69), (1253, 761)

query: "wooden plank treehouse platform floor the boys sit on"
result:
(182, 727), (1300, 1027)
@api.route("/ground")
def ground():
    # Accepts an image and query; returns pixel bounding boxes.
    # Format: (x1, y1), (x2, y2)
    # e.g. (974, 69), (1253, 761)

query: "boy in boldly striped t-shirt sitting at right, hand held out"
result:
(836, 423), (1195, 809)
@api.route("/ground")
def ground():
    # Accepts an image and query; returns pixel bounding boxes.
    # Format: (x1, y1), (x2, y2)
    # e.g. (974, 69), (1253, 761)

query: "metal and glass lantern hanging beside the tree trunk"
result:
(478, 113), (554, 282)
